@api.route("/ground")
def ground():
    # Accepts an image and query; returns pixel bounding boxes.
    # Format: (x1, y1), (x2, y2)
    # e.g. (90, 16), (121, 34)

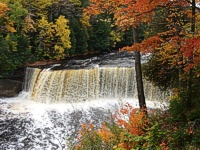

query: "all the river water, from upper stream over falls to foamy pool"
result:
(0, 54), (170, 150)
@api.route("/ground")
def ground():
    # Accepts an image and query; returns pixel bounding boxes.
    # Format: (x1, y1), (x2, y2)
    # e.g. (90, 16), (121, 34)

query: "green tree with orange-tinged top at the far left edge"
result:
(0, 2), (31, 76)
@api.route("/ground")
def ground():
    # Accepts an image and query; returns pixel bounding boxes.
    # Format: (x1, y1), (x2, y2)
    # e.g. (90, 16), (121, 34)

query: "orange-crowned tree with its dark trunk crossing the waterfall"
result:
(85, 0), (172, 108)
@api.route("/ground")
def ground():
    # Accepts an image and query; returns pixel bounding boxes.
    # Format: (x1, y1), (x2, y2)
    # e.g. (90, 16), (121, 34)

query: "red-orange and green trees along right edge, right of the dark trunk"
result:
(132, 1), (200, 122)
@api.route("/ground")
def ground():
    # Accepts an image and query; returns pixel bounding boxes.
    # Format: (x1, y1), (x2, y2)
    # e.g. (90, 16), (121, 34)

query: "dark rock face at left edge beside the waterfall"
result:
(0, 79), (22, 97)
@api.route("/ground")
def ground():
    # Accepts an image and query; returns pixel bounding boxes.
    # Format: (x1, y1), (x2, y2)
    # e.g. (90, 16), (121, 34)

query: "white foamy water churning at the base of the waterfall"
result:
(0, 92), (166, 150)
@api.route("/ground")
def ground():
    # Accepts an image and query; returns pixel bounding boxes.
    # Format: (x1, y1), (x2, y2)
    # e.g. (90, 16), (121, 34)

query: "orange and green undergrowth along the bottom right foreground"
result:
(74, 103), (200, 150)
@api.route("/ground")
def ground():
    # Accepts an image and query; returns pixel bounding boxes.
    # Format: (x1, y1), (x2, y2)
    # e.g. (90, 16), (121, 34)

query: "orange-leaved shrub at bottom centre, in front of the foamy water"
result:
(76, 103), (149, 150)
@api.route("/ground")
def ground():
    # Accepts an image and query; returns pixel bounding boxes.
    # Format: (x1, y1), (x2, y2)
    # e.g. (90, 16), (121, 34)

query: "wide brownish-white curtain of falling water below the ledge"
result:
(24, 67), (169, 103)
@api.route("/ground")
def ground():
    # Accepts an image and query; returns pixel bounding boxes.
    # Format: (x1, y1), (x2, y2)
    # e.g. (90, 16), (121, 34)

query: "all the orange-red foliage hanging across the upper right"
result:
(85, 0), (200, 76)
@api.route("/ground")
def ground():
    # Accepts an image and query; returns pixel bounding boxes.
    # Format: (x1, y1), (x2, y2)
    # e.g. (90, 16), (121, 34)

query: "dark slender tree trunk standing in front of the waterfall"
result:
(133, 28), (146, 111)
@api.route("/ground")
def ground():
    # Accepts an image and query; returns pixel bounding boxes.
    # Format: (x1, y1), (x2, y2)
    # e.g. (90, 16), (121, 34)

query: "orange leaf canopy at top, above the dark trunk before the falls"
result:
(84, 0), (170, 29)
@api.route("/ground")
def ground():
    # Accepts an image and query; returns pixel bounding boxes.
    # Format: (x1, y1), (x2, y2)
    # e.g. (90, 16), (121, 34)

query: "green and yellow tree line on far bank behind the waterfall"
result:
(0, 0), (133, 76)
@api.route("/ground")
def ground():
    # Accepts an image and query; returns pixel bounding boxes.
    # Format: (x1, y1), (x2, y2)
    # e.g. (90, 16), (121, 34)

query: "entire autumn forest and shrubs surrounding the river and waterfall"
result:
(0, 0), (200, 150)
